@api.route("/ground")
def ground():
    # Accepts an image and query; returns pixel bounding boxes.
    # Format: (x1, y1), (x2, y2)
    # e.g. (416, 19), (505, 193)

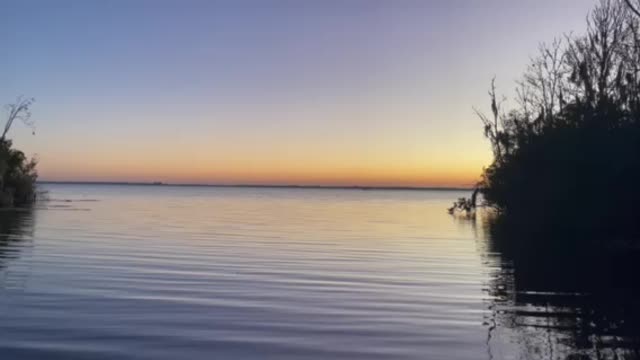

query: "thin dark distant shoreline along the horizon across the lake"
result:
(37, 181), (472, 191)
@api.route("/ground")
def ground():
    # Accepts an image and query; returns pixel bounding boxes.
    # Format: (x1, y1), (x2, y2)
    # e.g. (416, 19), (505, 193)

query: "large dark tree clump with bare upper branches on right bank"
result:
(451, 0), (640, 239)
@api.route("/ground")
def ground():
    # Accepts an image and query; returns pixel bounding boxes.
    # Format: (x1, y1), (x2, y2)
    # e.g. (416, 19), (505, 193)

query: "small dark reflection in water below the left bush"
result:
(0, 209), (34, 268)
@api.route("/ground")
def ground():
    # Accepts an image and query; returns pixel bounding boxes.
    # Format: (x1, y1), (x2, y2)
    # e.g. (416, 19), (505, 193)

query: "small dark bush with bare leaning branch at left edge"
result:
(0, 98), (38, 207)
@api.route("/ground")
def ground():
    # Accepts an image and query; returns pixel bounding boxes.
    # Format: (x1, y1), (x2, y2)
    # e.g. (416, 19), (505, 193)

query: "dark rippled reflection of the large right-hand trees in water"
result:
(484, 214), (640, 360)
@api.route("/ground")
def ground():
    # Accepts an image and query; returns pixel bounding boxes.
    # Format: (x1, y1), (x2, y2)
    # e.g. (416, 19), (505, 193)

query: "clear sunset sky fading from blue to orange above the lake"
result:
(0, 0), (595, 186)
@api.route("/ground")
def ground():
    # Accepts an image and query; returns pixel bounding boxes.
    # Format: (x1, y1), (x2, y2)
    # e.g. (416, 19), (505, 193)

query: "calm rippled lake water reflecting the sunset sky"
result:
(0, 185), (640, 359)
